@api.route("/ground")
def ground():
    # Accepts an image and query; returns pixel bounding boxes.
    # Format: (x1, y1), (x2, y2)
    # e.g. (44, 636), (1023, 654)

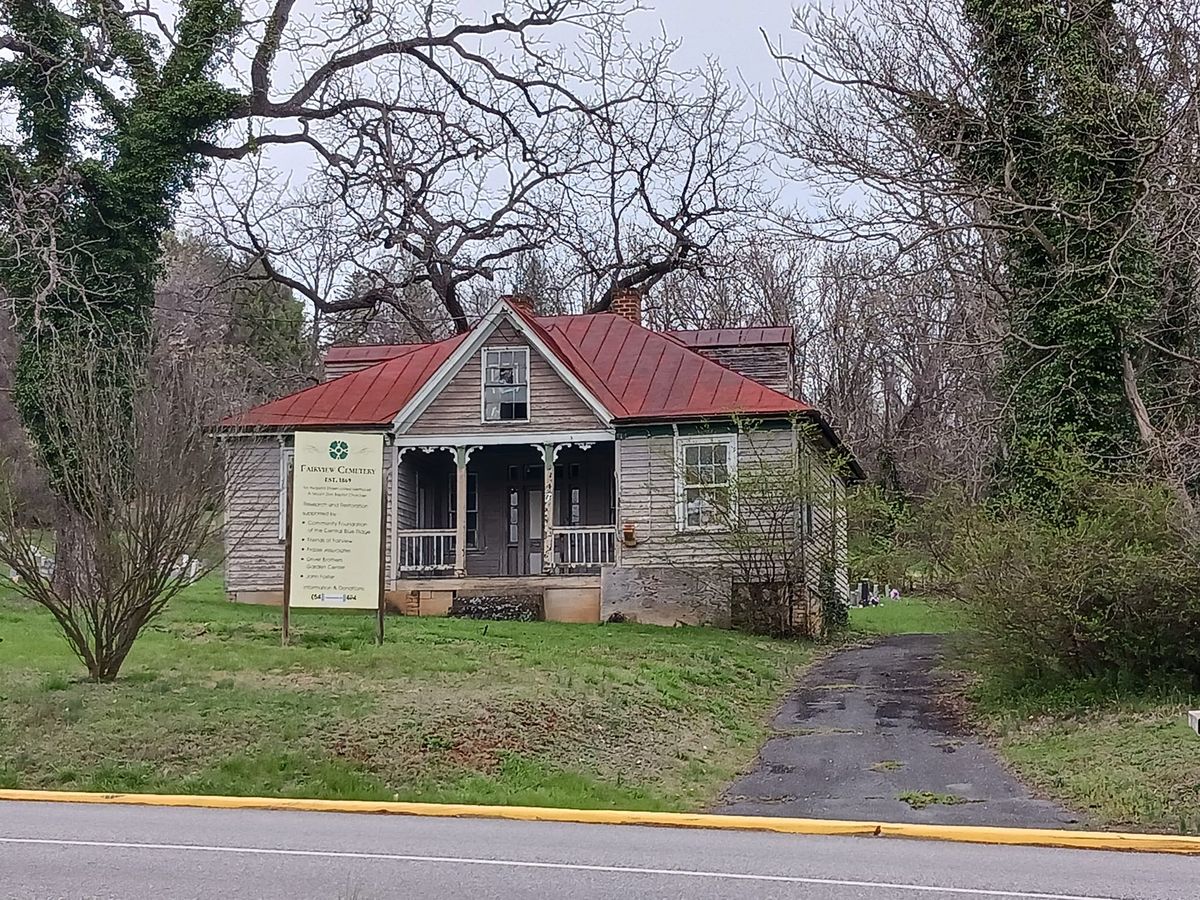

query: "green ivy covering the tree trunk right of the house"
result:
(913, 0), (1160, 514)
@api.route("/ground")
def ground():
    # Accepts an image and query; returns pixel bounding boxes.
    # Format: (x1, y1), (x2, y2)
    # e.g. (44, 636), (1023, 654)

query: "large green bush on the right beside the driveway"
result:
(949, 469), (1200, 685)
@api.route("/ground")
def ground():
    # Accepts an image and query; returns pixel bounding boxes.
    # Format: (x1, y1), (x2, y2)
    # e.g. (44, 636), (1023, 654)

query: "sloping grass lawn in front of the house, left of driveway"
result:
(0, 577), (812, 810)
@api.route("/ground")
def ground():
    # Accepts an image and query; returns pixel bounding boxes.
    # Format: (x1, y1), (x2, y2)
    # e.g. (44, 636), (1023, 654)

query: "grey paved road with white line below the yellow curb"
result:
(0, 802), (1200, 900)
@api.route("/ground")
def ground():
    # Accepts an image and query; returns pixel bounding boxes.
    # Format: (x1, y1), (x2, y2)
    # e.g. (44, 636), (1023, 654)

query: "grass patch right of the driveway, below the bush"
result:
(973, 678), (1200, 834)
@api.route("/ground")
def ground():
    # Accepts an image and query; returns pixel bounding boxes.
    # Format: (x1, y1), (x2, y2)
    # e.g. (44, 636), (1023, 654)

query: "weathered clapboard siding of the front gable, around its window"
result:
(408, 322), (602, 434)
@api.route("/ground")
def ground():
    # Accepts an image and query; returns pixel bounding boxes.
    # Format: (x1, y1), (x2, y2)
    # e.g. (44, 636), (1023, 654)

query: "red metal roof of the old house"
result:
(226, 306), (812, 427)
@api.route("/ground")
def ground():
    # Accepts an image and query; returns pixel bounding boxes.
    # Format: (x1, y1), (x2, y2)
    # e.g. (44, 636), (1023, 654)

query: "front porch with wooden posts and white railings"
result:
(392, 440), (617, 580)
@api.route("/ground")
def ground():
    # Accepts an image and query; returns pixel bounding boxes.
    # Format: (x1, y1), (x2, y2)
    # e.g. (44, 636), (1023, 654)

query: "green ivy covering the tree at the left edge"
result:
(0, 0), (240, 469)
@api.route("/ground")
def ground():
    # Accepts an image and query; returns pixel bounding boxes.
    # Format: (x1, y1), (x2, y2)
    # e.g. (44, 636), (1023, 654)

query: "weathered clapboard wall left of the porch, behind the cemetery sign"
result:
(224, 439), (403, 593)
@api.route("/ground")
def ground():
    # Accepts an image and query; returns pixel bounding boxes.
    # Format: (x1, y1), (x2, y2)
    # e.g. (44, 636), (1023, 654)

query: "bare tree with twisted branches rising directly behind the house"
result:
(192, 16), (761, 334)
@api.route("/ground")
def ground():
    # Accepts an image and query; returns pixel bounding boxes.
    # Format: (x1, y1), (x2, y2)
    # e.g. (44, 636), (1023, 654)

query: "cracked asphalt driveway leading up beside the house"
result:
(718, 635), (1075, 830)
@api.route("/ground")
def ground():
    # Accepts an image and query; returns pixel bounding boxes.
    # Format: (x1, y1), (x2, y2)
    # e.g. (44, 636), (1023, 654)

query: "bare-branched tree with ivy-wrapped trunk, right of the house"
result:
(762, 0), (1200, 508)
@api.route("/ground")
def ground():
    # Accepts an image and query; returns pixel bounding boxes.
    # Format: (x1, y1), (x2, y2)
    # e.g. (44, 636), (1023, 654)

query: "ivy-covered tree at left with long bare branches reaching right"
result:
(0, 0), (652, 451)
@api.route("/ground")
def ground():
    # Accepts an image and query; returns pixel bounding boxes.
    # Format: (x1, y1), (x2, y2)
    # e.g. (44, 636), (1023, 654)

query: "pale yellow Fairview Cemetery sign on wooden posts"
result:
(287, 431), (384, 610)
